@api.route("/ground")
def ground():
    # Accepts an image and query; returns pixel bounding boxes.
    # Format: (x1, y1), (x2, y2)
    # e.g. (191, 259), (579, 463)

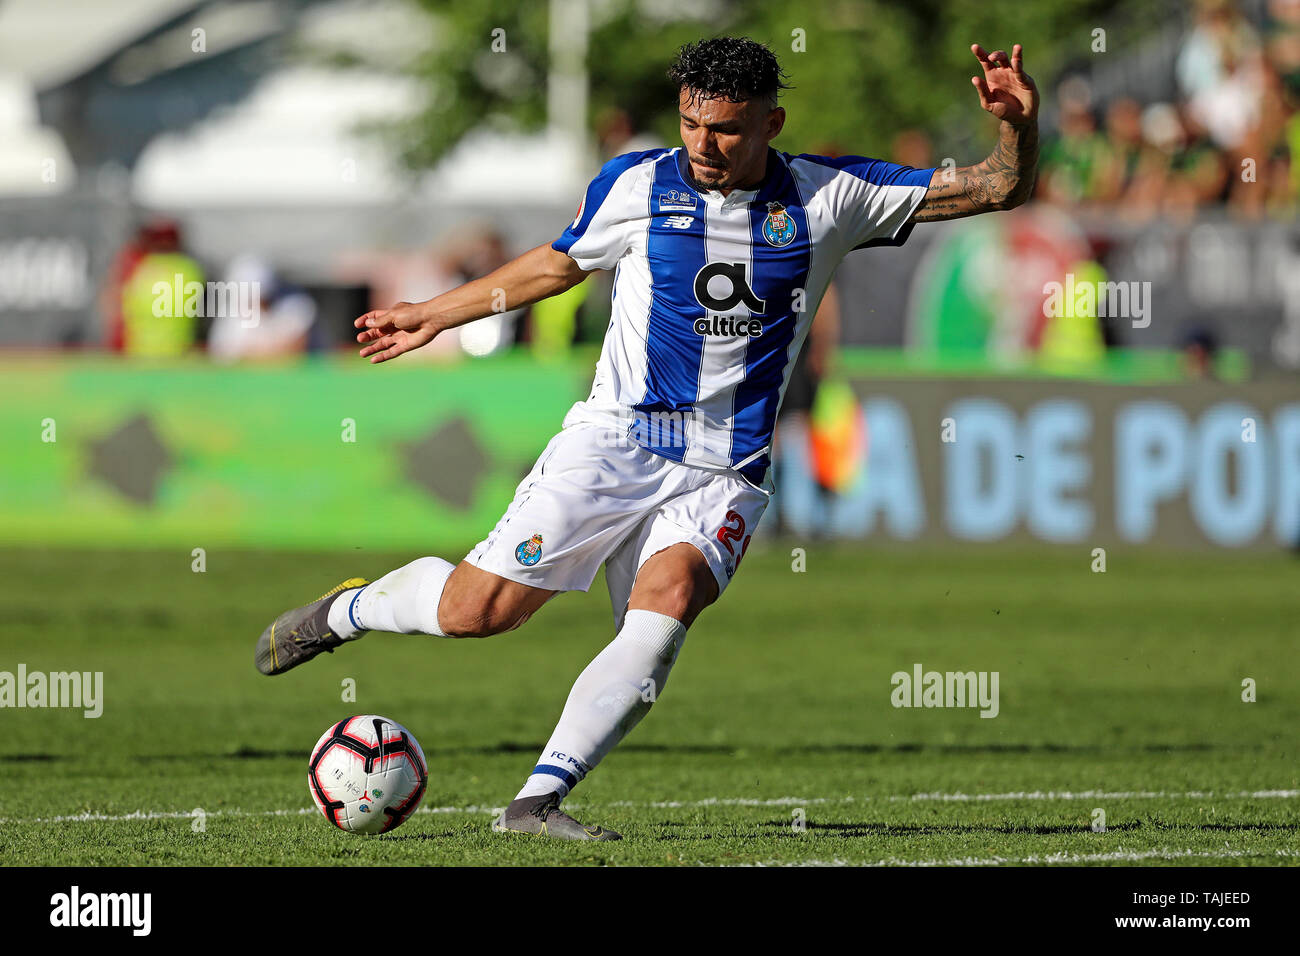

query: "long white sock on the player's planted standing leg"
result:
(515, 610), (686, 800)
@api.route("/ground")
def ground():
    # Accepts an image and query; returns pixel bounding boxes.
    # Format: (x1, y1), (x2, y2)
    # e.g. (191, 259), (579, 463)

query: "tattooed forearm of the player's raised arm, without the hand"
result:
(913, 122), (1039, 222)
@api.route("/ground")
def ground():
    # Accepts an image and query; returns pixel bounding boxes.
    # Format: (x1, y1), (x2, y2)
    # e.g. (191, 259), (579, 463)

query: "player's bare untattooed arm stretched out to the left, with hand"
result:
(354, 243), (590, 364)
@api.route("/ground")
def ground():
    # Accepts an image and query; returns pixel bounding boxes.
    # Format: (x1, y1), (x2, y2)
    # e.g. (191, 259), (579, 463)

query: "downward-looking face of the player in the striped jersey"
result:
(677, 90), (785, 193)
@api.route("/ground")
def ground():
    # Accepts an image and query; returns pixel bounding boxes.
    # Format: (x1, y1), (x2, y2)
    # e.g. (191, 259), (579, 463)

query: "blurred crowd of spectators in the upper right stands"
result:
(1037, 0), (1300, 220)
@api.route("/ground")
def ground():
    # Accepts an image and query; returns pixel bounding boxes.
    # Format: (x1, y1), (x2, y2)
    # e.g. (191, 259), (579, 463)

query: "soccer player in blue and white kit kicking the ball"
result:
(255, 38), (1039, 840)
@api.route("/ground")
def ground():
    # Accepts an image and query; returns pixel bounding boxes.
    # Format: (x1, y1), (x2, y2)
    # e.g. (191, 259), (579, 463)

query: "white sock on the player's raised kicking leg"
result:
(329, 558), (455, 641)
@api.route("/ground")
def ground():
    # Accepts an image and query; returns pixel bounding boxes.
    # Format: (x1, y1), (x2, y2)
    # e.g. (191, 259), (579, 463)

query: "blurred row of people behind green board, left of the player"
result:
(99, 217), (610, 363)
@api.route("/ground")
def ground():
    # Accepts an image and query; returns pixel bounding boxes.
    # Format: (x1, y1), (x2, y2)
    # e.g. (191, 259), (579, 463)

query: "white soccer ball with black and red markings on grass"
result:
(307, 714), (429, 834)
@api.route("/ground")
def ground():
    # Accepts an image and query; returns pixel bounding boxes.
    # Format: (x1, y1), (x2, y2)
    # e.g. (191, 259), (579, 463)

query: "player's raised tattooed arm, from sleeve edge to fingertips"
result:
(911, 43), (1039, 222)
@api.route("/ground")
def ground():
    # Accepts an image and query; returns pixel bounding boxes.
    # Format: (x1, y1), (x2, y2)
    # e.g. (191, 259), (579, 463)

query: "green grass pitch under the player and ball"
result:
(0, 542), (1300, 865)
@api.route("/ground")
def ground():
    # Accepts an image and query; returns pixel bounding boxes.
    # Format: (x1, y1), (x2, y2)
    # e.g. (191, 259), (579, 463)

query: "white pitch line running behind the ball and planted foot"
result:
(0, 790), (1300, 825)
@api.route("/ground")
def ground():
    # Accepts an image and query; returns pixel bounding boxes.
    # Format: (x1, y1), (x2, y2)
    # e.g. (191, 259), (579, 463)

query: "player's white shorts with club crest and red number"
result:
(465, 423), (771, 628)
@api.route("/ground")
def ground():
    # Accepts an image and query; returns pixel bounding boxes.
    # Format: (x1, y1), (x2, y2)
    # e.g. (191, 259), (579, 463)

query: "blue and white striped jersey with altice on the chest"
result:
(553, 147), (933, 484)
